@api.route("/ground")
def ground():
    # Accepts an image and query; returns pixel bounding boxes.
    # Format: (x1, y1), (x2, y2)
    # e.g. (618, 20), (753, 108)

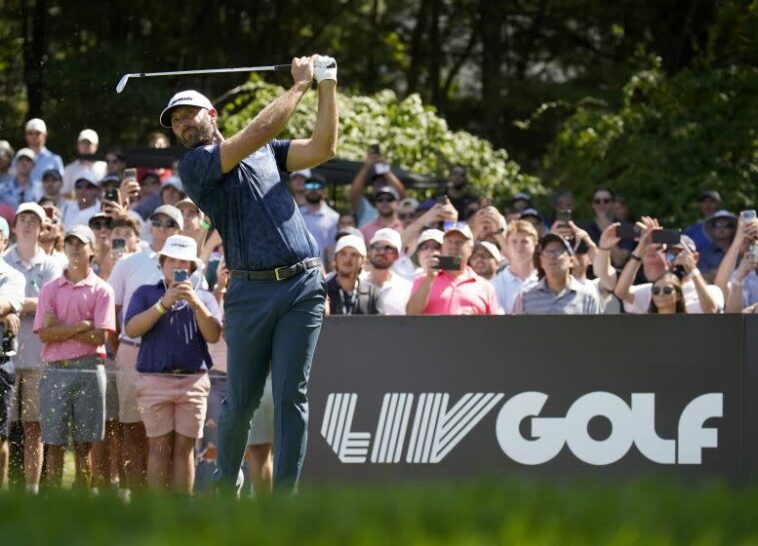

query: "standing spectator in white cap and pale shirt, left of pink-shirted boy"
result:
(4, 203), (63, 494)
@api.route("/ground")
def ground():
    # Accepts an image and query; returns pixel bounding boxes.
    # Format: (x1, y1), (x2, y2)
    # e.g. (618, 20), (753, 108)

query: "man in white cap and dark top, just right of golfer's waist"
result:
(326, 235), (384, 315)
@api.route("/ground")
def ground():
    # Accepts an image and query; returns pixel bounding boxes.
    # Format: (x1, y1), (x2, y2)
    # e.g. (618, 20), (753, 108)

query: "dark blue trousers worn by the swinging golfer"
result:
(217, 268), (326, 492)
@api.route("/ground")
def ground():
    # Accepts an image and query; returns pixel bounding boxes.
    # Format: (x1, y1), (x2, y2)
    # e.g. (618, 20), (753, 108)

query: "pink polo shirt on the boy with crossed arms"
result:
(34, 270), (116, 362)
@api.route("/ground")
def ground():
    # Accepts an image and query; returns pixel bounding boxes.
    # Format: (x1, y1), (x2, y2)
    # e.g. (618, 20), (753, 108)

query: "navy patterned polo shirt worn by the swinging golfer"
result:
(179, 140), (319, 271)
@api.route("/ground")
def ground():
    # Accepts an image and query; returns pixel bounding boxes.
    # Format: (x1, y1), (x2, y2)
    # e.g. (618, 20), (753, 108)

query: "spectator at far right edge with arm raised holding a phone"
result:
(715, 217), (758, 313)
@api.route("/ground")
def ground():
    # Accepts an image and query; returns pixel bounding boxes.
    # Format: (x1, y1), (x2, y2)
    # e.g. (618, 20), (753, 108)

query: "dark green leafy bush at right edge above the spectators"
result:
(544, 63), (758, 225)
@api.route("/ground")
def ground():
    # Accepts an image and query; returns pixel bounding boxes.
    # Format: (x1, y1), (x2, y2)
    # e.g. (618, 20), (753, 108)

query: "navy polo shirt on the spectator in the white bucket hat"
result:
(124, 280), (221, 373)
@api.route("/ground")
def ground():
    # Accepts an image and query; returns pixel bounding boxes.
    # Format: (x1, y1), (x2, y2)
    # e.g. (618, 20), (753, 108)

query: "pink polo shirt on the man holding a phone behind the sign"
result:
(411, 267), (500, 315)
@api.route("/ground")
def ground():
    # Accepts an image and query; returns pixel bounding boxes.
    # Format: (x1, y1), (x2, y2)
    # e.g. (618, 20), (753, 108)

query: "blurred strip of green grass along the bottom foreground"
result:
(0, 481), (758, 546)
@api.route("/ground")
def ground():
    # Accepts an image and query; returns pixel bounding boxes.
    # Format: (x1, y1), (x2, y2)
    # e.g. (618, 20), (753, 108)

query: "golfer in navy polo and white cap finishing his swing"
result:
(160, 56), (337, 492)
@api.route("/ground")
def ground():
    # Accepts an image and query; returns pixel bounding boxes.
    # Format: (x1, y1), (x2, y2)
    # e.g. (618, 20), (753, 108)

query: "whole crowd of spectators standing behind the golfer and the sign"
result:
(0, 119), (758, 496)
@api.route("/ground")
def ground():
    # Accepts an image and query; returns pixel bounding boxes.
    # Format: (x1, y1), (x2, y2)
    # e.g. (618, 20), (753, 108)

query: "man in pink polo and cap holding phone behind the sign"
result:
(406, 224), (499, 315)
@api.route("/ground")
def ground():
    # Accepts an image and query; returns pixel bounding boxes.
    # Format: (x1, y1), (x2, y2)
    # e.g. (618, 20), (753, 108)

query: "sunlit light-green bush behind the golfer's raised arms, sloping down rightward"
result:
(221, 76), (544, 201)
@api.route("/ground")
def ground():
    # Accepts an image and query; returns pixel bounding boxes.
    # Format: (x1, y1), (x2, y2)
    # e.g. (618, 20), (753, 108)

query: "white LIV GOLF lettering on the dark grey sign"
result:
(321, 392), (724, 465)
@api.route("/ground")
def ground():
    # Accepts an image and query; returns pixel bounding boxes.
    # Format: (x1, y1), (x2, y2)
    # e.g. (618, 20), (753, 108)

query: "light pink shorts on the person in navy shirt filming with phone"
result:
(136, 373), (211, 438)
